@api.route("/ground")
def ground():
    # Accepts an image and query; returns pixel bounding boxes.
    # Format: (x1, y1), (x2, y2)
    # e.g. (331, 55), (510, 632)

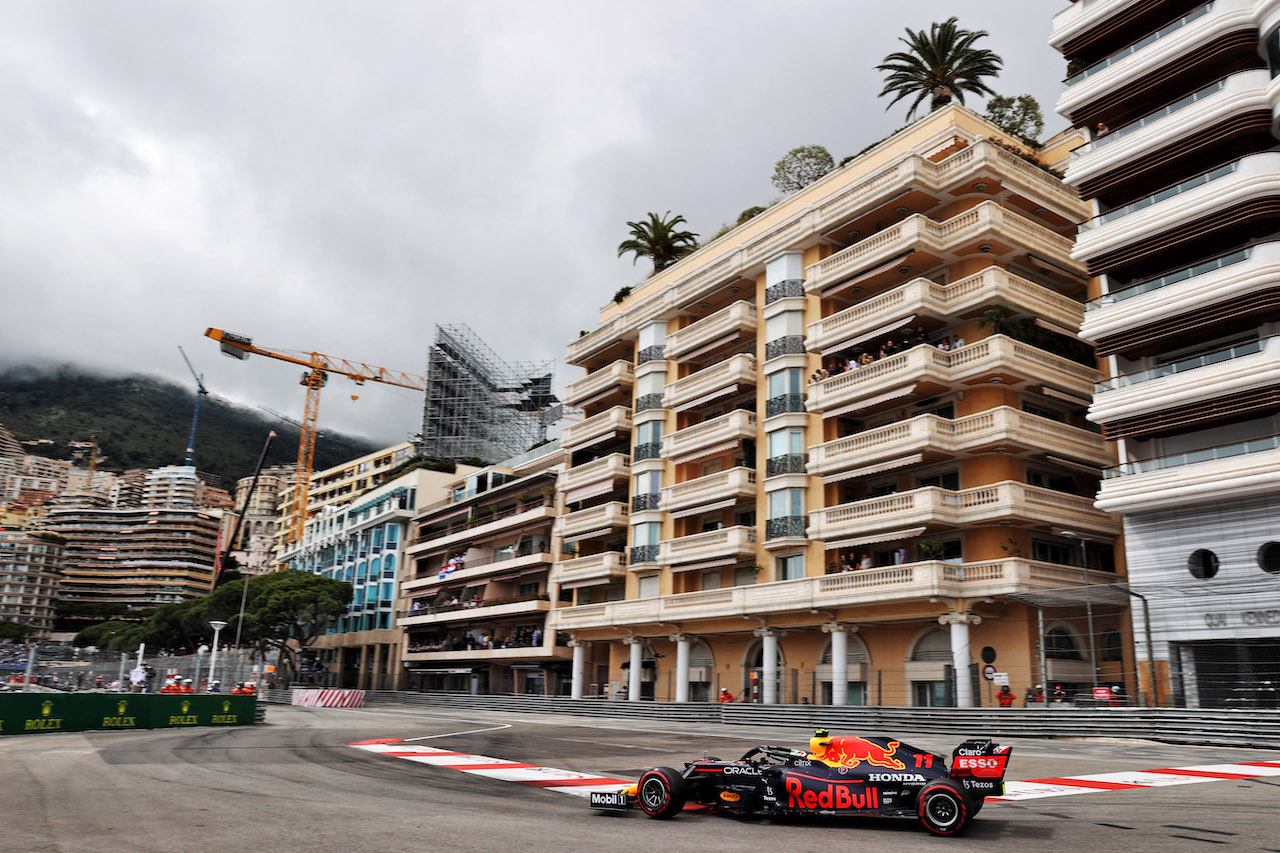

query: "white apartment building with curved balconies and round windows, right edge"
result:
(1051, 0), (1280, 707)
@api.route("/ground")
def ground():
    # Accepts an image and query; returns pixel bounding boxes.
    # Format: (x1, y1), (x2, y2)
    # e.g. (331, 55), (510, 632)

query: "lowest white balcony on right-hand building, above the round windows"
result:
(1098, 435), (1280, 514)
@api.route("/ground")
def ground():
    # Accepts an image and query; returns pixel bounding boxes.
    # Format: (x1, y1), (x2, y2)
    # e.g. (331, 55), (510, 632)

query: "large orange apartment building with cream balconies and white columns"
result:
(550, 105), (1134, 706)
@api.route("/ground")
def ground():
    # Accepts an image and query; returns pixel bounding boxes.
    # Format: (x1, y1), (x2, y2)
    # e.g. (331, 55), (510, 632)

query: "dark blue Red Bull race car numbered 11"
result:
(591, 729), (1011, 835)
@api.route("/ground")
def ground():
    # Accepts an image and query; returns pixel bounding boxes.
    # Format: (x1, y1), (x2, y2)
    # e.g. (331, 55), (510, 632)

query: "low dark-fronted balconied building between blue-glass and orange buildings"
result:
(397, 441), (570, 695)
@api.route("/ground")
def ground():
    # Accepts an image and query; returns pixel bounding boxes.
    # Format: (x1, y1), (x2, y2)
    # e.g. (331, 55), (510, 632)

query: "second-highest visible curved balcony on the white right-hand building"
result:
(1056, 0), (1258, 115)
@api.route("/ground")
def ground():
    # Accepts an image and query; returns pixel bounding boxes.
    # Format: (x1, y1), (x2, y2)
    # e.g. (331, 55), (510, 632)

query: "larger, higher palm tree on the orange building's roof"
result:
(876, 18), (1005, 119)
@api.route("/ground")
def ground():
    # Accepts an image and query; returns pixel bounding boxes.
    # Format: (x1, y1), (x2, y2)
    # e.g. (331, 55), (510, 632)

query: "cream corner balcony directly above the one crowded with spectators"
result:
(808, 266), (1084, 353)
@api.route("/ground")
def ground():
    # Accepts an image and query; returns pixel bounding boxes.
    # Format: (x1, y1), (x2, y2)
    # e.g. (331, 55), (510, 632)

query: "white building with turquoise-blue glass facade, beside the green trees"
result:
(282, 467), (453, 690)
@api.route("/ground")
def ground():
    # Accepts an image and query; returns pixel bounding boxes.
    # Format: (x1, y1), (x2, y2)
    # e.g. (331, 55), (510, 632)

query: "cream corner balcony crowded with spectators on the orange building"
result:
(808, 334), (1098, 412)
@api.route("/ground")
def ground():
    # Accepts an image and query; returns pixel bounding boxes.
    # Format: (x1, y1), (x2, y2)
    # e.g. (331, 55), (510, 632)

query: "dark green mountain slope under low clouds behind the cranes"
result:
(0, 366), (376, 489)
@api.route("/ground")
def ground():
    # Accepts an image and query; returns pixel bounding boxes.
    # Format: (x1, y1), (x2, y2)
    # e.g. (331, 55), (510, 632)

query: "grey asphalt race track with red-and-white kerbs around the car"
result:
(0, 706), (1280, 853)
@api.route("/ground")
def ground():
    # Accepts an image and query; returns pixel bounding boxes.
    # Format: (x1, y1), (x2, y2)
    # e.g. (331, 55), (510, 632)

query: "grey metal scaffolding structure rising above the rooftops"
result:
(419, 324), (563, 465)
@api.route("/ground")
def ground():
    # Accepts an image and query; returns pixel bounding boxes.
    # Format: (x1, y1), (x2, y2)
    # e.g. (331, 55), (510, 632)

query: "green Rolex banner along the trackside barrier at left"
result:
(0, 693), (257, 735)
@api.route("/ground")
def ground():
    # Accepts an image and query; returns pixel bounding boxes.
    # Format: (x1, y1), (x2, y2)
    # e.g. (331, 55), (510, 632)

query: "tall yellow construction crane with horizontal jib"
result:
(205, 329), (426, 543)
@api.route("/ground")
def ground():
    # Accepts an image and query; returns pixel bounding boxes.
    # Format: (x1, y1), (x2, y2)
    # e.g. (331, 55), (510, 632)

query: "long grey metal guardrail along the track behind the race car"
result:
(264, 690), (1280, 749)
